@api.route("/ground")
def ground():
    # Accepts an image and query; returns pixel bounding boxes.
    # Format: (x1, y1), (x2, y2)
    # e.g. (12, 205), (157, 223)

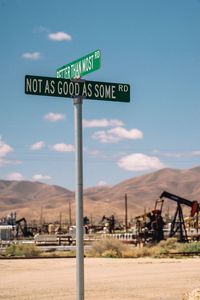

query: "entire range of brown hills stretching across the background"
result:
(0, 166), (200, 222)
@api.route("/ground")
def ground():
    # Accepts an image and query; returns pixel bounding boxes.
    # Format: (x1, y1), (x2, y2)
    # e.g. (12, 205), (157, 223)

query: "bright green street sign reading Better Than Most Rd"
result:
(56, 50), (101, 79)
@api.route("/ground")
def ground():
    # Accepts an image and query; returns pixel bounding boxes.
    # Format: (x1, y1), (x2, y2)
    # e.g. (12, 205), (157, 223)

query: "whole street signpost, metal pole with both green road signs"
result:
(25, 49), (130, 300)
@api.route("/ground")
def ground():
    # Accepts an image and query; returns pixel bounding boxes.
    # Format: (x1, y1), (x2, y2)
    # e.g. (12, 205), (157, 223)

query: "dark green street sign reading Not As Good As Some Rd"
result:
(25, 75), (130, 102)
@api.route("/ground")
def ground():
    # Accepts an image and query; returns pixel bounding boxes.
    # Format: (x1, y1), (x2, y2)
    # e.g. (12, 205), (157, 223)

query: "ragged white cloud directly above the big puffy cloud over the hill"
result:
(92, 127), (143, 144)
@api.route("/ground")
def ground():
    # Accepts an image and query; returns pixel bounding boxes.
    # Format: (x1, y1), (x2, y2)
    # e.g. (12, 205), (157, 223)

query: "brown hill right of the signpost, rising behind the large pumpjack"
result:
(85, 167), (200, 219)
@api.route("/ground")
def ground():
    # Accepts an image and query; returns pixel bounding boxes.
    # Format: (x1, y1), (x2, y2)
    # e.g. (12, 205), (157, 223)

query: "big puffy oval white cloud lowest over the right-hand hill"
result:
(117, 153), (165, 171)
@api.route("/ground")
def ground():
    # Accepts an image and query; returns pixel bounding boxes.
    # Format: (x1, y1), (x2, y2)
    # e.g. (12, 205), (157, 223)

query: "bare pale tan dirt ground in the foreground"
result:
(0, 258), (200, 300)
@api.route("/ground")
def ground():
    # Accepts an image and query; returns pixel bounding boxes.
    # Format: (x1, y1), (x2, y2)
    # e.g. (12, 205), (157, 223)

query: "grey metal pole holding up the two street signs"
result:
(74, 98), (84, 300)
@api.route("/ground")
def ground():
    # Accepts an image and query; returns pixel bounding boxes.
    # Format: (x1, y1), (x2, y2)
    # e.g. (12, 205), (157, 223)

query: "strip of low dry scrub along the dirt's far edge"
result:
(4, 238), (200, 258)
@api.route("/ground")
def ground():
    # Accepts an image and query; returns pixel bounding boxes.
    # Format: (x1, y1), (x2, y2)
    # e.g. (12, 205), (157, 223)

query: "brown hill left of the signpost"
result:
(0, 180), (74, 221)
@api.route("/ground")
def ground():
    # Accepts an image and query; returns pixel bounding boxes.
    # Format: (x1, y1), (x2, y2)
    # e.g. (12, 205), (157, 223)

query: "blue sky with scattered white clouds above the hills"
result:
(0, 0), (200, 190)
